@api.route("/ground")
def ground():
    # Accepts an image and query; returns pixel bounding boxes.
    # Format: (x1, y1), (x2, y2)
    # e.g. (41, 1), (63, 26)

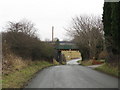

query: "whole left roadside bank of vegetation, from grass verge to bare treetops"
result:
(2, 20), (54, 88)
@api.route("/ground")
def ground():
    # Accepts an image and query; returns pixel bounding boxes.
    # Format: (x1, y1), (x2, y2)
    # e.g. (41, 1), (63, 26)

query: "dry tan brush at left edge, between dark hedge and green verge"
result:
(2, 52), (31, 75)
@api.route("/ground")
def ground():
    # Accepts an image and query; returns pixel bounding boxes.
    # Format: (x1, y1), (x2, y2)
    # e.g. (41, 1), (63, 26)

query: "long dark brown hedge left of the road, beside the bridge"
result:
(2, 31), (54, 62)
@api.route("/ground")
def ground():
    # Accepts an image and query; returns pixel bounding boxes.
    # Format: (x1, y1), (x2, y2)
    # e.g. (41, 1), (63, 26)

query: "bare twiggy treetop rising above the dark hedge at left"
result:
(6, 19), (37, 36)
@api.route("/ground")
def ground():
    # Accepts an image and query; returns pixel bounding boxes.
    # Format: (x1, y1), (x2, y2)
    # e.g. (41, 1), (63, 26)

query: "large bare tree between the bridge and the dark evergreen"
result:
(67, 16), (103, 58)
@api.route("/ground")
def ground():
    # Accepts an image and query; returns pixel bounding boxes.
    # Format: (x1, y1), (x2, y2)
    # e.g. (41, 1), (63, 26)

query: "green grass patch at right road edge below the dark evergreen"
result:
(95, 63), (120, 77)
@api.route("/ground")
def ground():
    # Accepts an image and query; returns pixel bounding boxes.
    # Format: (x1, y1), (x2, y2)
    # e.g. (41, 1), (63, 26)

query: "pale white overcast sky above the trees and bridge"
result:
(0, 0), (104, 40)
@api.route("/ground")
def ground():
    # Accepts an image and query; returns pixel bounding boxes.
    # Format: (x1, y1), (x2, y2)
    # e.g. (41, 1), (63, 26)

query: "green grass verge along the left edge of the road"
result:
(2, 61), (53, 88)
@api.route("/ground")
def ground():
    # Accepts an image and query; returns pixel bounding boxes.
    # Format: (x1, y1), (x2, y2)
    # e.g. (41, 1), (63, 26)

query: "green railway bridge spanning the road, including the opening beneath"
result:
(55, 41), (81, 63)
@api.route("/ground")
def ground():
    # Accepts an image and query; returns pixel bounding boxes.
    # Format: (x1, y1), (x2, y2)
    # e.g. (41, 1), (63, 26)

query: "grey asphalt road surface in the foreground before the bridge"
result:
(25, 65), (118, 88)
